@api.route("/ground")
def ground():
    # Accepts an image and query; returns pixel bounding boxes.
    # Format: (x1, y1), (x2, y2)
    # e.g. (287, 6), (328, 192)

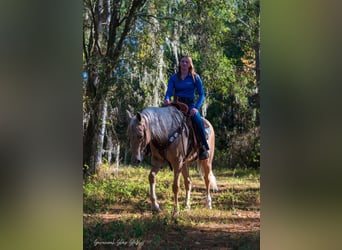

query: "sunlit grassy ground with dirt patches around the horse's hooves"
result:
(83, 166), (260, 249)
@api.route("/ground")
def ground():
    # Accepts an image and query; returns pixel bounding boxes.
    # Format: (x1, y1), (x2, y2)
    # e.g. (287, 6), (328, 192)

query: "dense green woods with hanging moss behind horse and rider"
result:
(83, 0), (260, 174)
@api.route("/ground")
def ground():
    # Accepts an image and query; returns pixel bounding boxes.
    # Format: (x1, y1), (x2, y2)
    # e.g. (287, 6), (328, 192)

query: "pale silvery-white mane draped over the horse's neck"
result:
(141, 106), (184, 143)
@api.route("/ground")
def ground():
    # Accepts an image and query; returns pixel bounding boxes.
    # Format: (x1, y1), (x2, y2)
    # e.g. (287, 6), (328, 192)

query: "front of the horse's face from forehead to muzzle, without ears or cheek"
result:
(128, 114), (146, 163)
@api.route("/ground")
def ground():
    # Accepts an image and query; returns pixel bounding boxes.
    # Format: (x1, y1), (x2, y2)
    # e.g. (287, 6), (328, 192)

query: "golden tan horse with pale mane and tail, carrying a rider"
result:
(127, 106), (217, 214)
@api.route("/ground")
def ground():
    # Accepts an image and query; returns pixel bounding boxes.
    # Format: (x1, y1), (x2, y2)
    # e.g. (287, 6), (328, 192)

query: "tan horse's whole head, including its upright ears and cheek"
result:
(127, 112), (150, 163)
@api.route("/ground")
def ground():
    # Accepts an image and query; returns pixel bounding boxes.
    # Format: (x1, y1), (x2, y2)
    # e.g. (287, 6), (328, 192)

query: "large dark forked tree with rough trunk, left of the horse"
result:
(83, 0), (146, 174)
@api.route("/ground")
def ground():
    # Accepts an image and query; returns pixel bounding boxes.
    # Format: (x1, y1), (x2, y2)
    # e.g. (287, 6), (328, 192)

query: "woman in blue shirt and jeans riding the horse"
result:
(164, 56), (209, 160)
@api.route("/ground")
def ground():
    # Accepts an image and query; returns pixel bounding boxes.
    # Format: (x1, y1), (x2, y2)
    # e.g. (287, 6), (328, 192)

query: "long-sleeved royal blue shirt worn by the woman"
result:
(164, 73), (205, 109)
